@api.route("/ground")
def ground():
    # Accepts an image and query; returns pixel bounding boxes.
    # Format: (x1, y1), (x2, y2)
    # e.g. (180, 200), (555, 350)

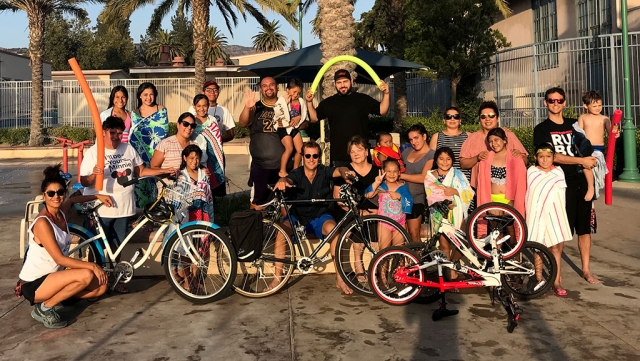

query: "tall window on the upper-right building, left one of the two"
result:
(531, 0), (558, 69)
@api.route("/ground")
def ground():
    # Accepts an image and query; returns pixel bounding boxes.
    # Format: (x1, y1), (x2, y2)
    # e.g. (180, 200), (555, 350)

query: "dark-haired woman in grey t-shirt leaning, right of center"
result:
(400, 124), (434, 242)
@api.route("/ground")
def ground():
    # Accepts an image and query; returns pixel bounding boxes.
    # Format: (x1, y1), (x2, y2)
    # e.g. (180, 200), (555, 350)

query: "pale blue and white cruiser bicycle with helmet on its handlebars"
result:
(69, 176), (236, 303)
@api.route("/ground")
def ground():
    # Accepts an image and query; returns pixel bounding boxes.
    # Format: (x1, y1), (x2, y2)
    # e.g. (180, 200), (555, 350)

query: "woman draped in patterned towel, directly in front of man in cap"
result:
(191, 94), (225, 194)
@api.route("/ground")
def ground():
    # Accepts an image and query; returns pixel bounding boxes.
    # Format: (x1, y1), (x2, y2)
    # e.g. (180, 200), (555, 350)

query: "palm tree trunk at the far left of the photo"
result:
(27, 11), (46, 147)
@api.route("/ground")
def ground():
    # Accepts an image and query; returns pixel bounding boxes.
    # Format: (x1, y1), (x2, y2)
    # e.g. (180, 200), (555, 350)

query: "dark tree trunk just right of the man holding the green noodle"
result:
(387, 0), (407, 131)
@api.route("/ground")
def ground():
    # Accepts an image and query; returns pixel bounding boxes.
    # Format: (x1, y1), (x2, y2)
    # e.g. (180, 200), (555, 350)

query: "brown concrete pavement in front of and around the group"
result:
(0, 156), (640, 361)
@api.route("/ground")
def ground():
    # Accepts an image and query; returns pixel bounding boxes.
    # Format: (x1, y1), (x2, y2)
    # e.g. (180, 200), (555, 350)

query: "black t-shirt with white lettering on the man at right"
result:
(533, 117), (585, 187)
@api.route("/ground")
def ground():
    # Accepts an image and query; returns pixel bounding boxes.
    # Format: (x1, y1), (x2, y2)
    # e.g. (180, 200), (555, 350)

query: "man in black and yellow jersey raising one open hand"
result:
(238, 77), (284, 209)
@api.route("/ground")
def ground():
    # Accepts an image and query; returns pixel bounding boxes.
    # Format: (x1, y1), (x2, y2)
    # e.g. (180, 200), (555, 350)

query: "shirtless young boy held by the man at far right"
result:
(574, 90), (620, 201)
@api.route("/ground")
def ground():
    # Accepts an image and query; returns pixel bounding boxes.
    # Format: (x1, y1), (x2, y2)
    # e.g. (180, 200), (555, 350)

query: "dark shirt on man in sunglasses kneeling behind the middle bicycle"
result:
(287, 164), (335, 225)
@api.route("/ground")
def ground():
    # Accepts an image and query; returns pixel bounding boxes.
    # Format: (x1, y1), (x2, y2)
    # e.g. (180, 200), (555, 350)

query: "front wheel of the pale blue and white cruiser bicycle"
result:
(163, 224), (237, 304)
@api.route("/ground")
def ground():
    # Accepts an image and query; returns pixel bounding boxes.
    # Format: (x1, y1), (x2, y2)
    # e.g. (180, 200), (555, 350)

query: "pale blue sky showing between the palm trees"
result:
(0, 0), (374, 48)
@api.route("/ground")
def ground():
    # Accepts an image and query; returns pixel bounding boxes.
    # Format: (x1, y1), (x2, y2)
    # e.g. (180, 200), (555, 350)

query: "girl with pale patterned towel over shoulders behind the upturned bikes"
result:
(424, 147), (473, 279)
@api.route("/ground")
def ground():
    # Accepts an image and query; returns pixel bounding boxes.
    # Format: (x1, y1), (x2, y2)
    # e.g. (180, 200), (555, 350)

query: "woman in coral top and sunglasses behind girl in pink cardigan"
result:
(460, 101), (529, 188)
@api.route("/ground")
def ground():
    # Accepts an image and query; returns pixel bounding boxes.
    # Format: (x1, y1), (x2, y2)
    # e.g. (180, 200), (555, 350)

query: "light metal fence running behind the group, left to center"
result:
(0, 73), (450, 128)
